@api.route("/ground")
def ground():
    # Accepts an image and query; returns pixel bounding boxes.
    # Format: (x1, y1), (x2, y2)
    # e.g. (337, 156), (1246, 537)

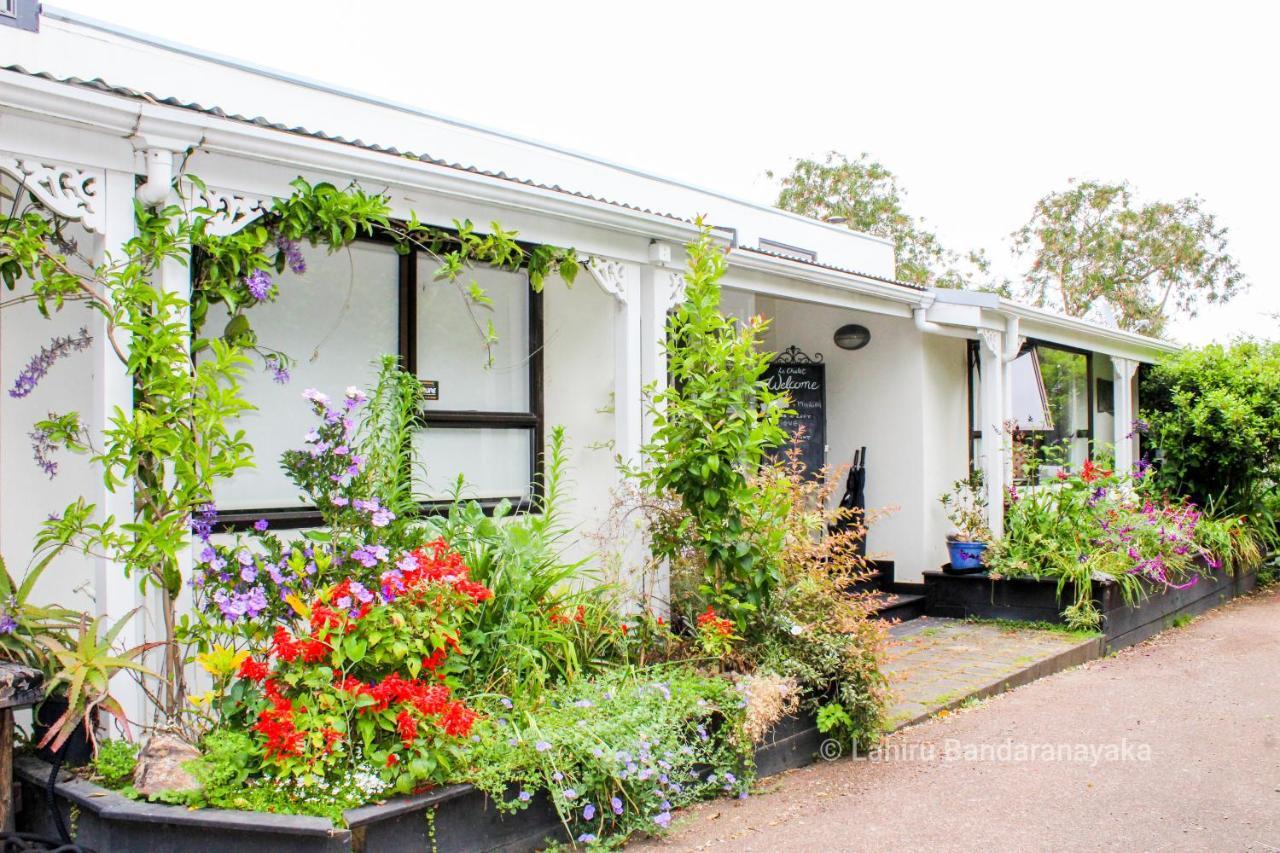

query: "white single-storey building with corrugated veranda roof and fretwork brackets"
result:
(0, 0), (1170, 701)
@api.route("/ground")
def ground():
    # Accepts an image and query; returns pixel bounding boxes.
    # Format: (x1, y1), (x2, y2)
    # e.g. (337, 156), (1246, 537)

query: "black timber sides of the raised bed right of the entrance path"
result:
(924, 560), (1257, 652)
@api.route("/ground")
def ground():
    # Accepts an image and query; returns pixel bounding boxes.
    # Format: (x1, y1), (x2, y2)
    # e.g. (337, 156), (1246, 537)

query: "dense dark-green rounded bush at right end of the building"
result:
(1140, 341), (1280, 515)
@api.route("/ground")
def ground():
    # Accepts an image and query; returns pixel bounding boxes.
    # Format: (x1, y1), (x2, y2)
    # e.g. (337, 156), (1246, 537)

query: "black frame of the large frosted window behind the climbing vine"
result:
(218, 234), (547, 532)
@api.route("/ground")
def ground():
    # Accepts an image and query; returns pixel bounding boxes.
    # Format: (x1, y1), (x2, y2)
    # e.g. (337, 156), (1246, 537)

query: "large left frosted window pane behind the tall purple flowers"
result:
(210, 242), (399, 510)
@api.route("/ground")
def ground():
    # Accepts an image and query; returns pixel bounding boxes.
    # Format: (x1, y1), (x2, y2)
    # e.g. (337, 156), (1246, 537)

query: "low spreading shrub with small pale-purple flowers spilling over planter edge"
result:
(471, 665), (755, 844)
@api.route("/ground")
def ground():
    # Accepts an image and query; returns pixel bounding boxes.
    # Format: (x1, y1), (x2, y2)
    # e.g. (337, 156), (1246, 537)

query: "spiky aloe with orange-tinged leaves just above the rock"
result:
(38, 608), (163, 753)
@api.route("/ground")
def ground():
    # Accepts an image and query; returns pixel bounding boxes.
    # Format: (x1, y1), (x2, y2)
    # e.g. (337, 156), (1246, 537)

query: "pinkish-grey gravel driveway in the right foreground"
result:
(628, 581), (1280, 853)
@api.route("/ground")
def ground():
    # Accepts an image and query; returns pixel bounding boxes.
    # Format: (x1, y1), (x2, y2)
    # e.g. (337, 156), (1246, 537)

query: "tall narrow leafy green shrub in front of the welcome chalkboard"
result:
(639, 229), (788, 629)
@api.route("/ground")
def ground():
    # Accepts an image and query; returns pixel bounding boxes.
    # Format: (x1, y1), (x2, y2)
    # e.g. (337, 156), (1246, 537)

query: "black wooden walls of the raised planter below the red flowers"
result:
(15, 716), (822, 853)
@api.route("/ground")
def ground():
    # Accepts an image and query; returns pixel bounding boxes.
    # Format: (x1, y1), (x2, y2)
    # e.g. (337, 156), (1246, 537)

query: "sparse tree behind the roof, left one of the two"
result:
(768, 151), (988, 287)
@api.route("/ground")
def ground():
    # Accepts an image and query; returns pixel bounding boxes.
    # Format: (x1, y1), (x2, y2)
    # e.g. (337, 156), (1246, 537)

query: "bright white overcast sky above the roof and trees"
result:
(45, 0), (1280, 343)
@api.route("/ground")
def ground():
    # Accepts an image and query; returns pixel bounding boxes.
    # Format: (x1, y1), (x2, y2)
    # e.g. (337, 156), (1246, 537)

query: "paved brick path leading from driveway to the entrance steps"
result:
(884, 617), (1102, 729)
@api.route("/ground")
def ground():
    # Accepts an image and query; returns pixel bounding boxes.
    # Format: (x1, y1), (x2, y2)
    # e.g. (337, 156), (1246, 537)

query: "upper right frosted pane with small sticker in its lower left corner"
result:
(417, 266), (530, 412)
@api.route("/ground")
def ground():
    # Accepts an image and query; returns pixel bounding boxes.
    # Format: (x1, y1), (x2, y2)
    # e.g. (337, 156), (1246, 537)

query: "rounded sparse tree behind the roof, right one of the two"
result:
(1012, 182), (1247, 336)
